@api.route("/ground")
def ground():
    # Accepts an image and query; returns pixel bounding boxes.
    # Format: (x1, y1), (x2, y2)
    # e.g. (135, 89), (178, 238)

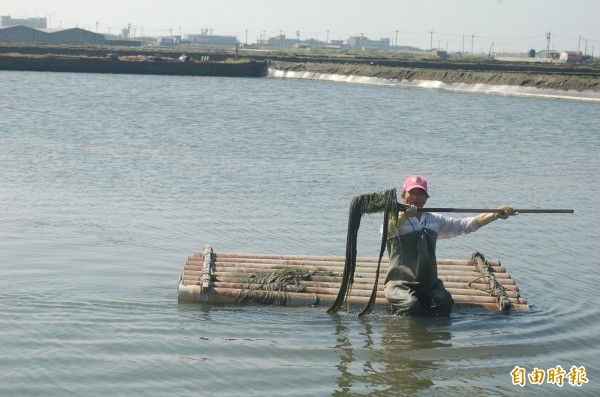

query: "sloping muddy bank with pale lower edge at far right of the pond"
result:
(270, 61), (600, 92)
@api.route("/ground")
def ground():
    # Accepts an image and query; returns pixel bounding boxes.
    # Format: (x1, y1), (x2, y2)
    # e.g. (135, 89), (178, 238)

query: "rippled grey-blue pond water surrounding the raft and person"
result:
(0, 72), (600, 396)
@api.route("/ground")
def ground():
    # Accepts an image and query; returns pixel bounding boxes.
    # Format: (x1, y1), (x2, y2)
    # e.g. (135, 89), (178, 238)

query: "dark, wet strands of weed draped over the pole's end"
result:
(327, 189), (403, 316)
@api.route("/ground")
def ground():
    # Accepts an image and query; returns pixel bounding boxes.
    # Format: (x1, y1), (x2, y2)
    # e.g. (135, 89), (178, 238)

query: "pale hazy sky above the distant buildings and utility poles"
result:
(0, 0), (600, 55)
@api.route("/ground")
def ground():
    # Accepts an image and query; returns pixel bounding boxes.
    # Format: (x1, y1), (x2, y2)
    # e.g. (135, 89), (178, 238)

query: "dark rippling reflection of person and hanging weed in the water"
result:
(332, 316), (451, 396)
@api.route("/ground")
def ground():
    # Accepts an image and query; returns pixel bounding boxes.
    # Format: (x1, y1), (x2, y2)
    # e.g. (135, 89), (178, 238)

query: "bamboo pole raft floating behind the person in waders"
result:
(177, 245), (529, 312)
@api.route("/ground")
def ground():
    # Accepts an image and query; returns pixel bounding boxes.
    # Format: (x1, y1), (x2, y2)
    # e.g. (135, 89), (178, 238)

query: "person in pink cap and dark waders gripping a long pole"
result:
(384, 175), (516, 316)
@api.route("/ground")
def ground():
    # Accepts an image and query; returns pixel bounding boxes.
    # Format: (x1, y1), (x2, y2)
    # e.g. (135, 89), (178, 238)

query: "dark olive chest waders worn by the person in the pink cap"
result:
(384, 228), (454, 316)
